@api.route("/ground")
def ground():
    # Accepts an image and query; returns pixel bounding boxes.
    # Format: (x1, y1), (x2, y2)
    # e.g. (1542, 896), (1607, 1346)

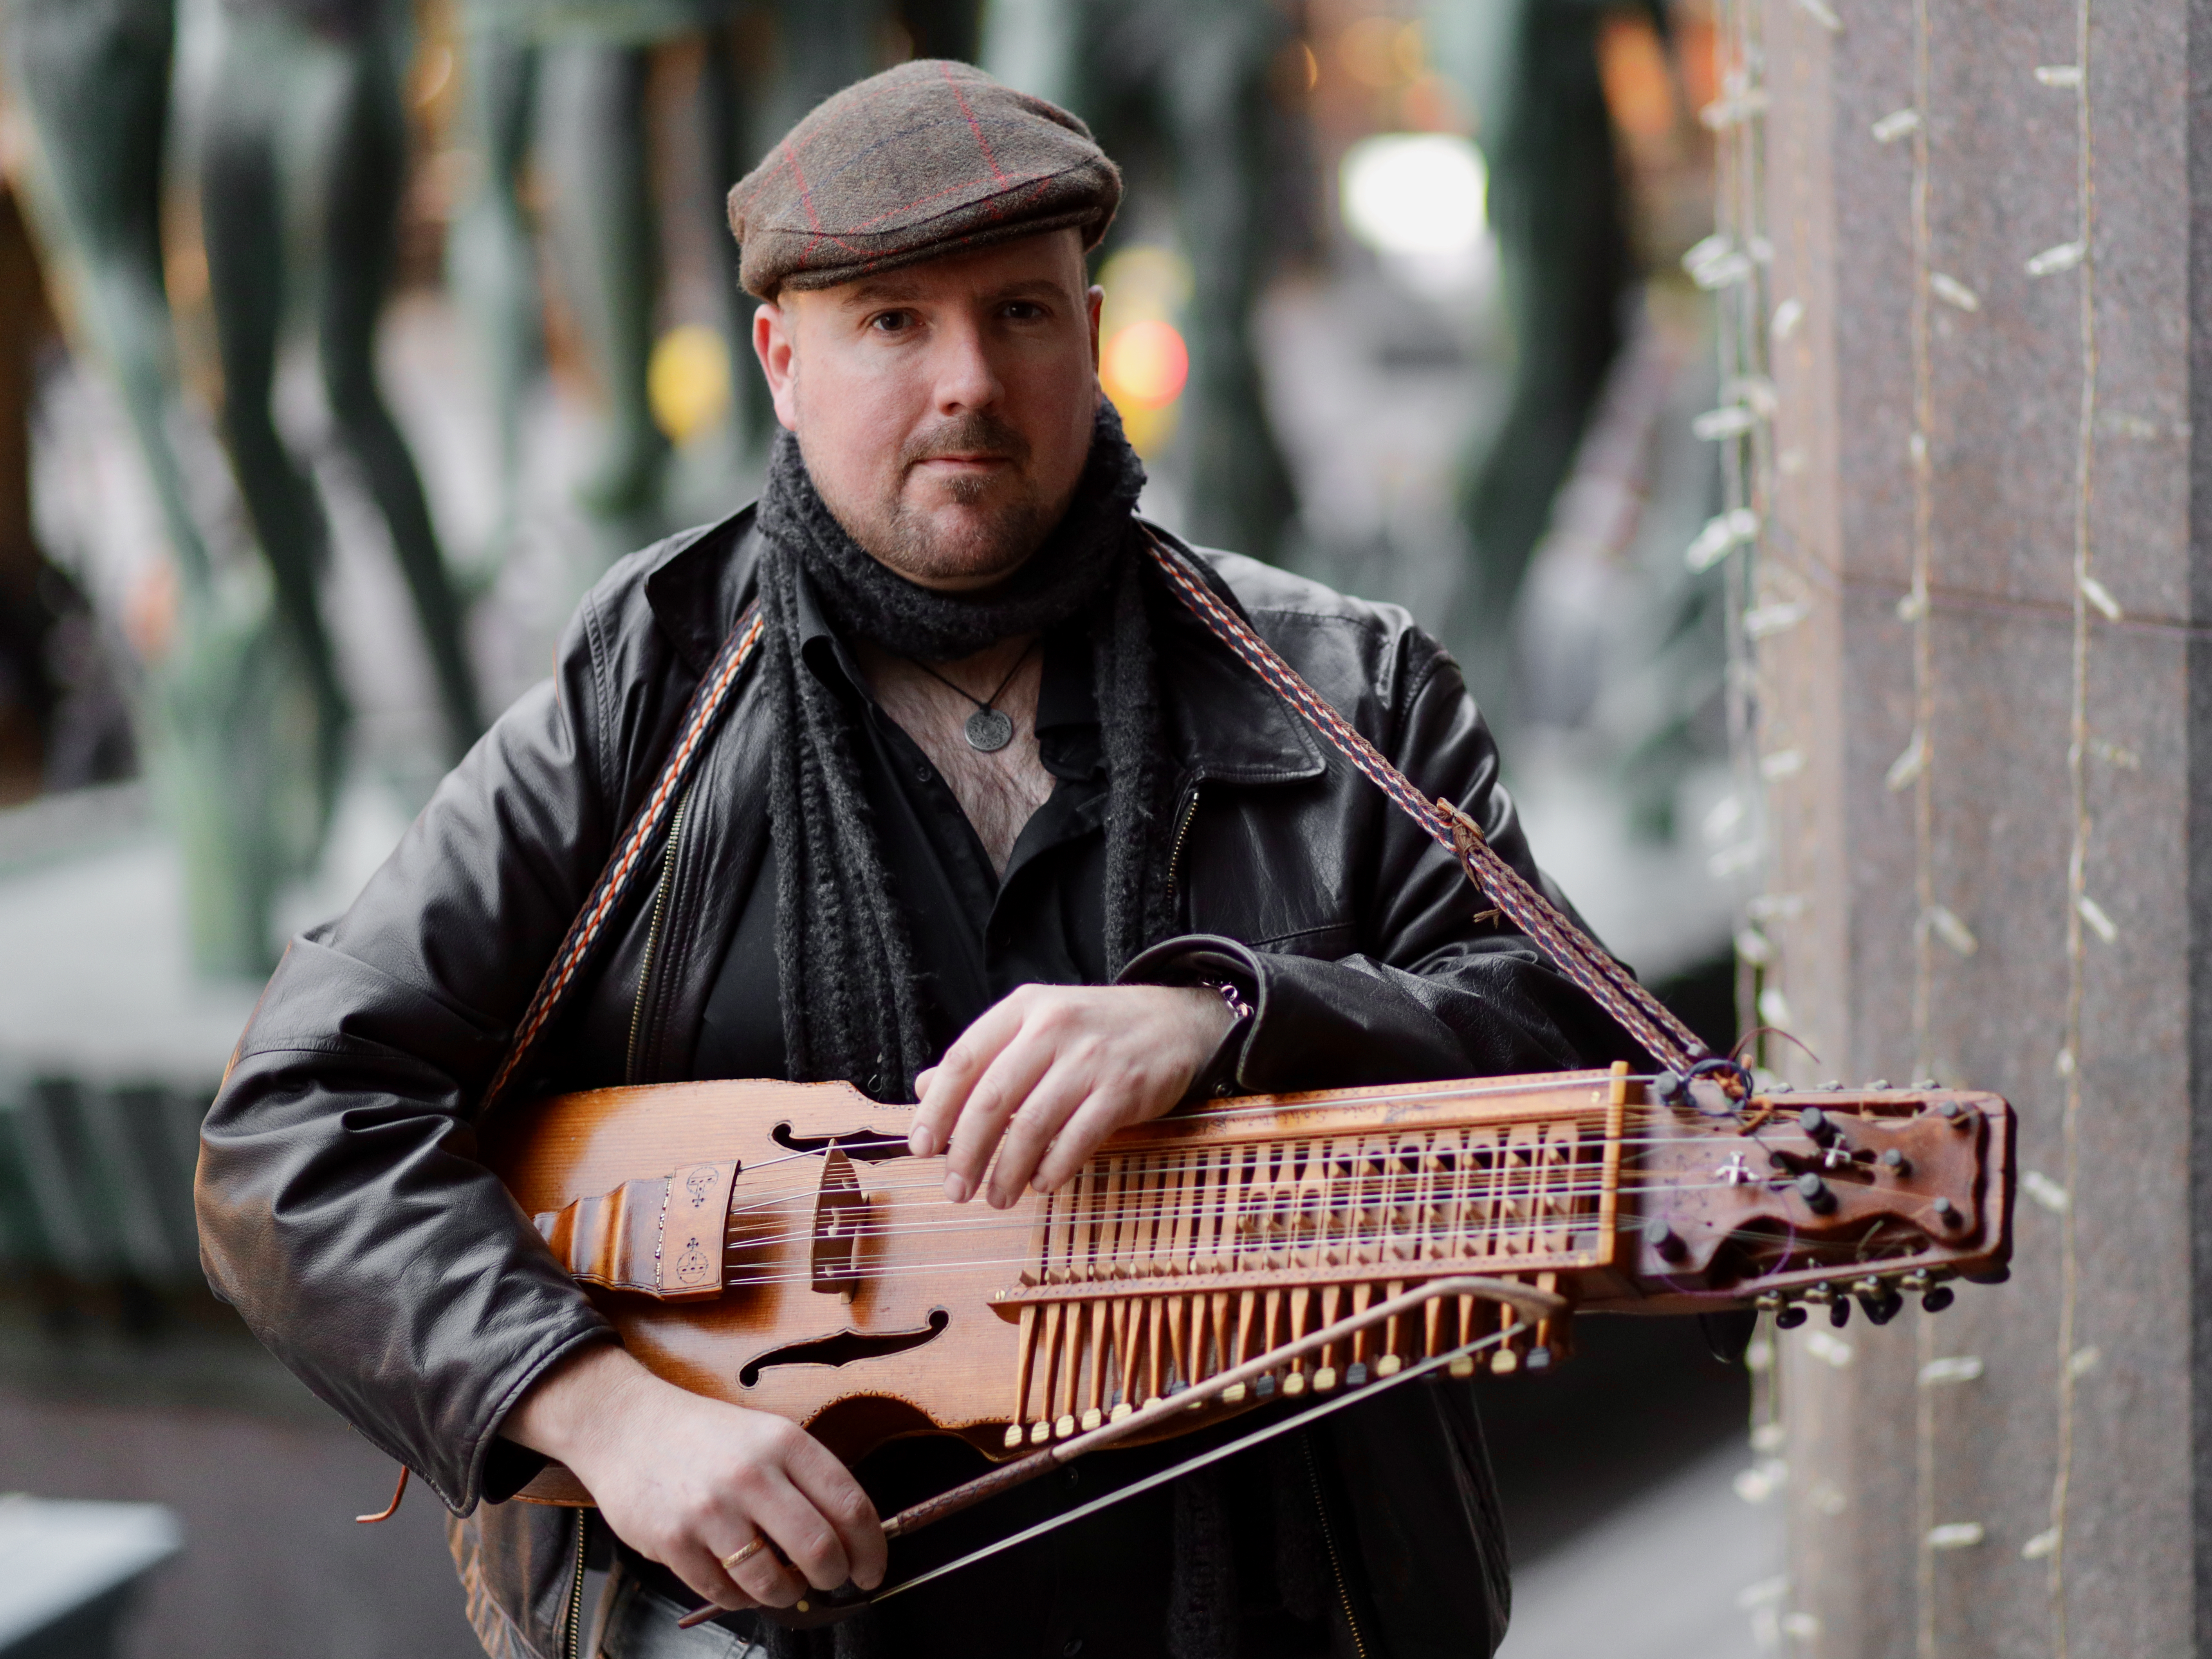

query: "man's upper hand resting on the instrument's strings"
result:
(911, 985), (1234, 1210)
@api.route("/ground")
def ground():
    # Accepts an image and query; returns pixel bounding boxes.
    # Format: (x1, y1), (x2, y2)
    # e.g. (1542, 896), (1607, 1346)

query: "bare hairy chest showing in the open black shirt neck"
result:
(854, 637), (1053, 878)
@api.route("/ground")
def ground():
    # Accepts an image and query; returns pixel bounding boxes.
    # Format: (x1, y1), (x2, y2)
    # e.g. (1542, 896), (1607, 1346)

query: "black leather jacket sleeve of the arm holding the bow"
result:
(197, 599), (650, 1513)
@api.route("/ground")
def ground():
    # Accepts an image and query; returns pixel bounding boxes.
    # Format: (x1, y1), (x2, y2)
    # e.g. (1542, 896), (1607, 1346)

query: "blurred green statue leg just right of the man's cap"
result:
(984, 0), (1296, 560)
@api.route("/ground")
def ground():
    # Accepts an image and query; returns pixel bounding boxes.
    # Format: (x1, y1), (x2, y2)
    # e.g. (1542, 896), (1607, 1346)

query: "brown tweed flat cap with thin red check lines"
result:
(730, 58), (1122, 299)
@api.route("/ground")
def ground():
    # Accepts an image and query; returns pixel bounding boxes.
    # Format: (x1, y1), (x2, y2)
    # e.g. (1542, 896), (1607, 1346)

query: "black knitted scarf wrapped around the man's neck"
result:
(759, 405), (1175, 1099)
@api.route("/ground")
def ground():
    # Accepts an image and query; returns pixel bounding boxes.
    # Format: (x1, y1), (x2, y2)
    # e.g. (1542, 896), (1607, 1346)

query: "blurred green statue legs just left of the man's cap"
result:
(451, 0), (976, 553)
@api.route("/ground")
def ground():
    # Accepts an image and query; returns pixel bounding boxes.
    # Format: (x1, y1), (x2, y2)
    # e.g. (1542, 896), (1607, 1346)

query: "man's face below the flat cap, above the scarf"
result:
(752, 230), (1099, 593)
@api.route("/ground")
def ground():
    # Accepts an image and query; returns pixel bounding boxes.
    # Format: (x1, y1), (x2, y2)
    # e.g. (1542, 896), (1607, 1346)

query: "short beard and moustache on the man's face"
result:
(801, 411), (1073, 582)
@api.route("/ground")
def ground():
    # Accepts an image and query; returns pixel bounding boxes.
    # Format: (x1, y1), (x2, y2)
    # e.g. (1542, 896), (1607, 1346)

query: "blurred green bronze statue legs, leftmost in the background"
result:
(4, 0), (480, 976)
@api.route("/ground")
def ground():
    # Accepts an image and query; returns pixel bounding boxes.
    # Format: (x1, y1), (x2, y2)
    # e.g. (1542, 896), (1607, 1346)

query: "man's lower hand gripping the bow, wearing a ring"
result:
(500, 1343), (885, 1608)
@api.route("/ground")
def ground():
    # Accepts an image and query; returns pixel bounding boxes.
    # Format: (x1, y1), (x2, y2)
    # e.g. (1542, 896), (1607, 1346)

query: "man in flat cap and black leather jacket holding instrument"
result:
(199, 62), (1645, 1659)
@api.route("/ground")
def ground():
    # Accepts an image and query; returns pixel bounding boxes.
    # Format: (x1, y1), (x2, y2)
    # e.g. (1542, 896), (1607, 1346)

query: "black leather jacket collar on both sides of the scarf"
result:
(639, 507), (1325, 783)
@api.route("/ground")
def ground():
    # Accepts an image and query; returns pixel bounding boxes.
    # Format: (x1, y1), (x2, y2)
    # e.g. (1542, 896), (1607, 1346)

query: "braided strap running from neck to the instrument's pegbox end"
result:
(1146, 531), (1708, 1073)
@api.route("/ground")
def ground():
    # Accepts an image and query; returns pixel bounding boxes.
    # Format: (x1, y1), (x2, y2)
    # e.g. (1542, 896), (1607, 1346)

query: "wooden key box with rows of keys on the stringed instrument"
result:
(1000, 1111), (1613, 1447)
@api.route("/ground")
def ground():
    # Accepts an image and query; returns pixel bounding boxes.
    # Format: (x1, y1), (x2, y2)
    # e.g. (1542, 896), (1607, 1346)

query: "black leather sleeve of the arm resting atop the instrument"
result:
(1122, 628), (1648, 1093)
